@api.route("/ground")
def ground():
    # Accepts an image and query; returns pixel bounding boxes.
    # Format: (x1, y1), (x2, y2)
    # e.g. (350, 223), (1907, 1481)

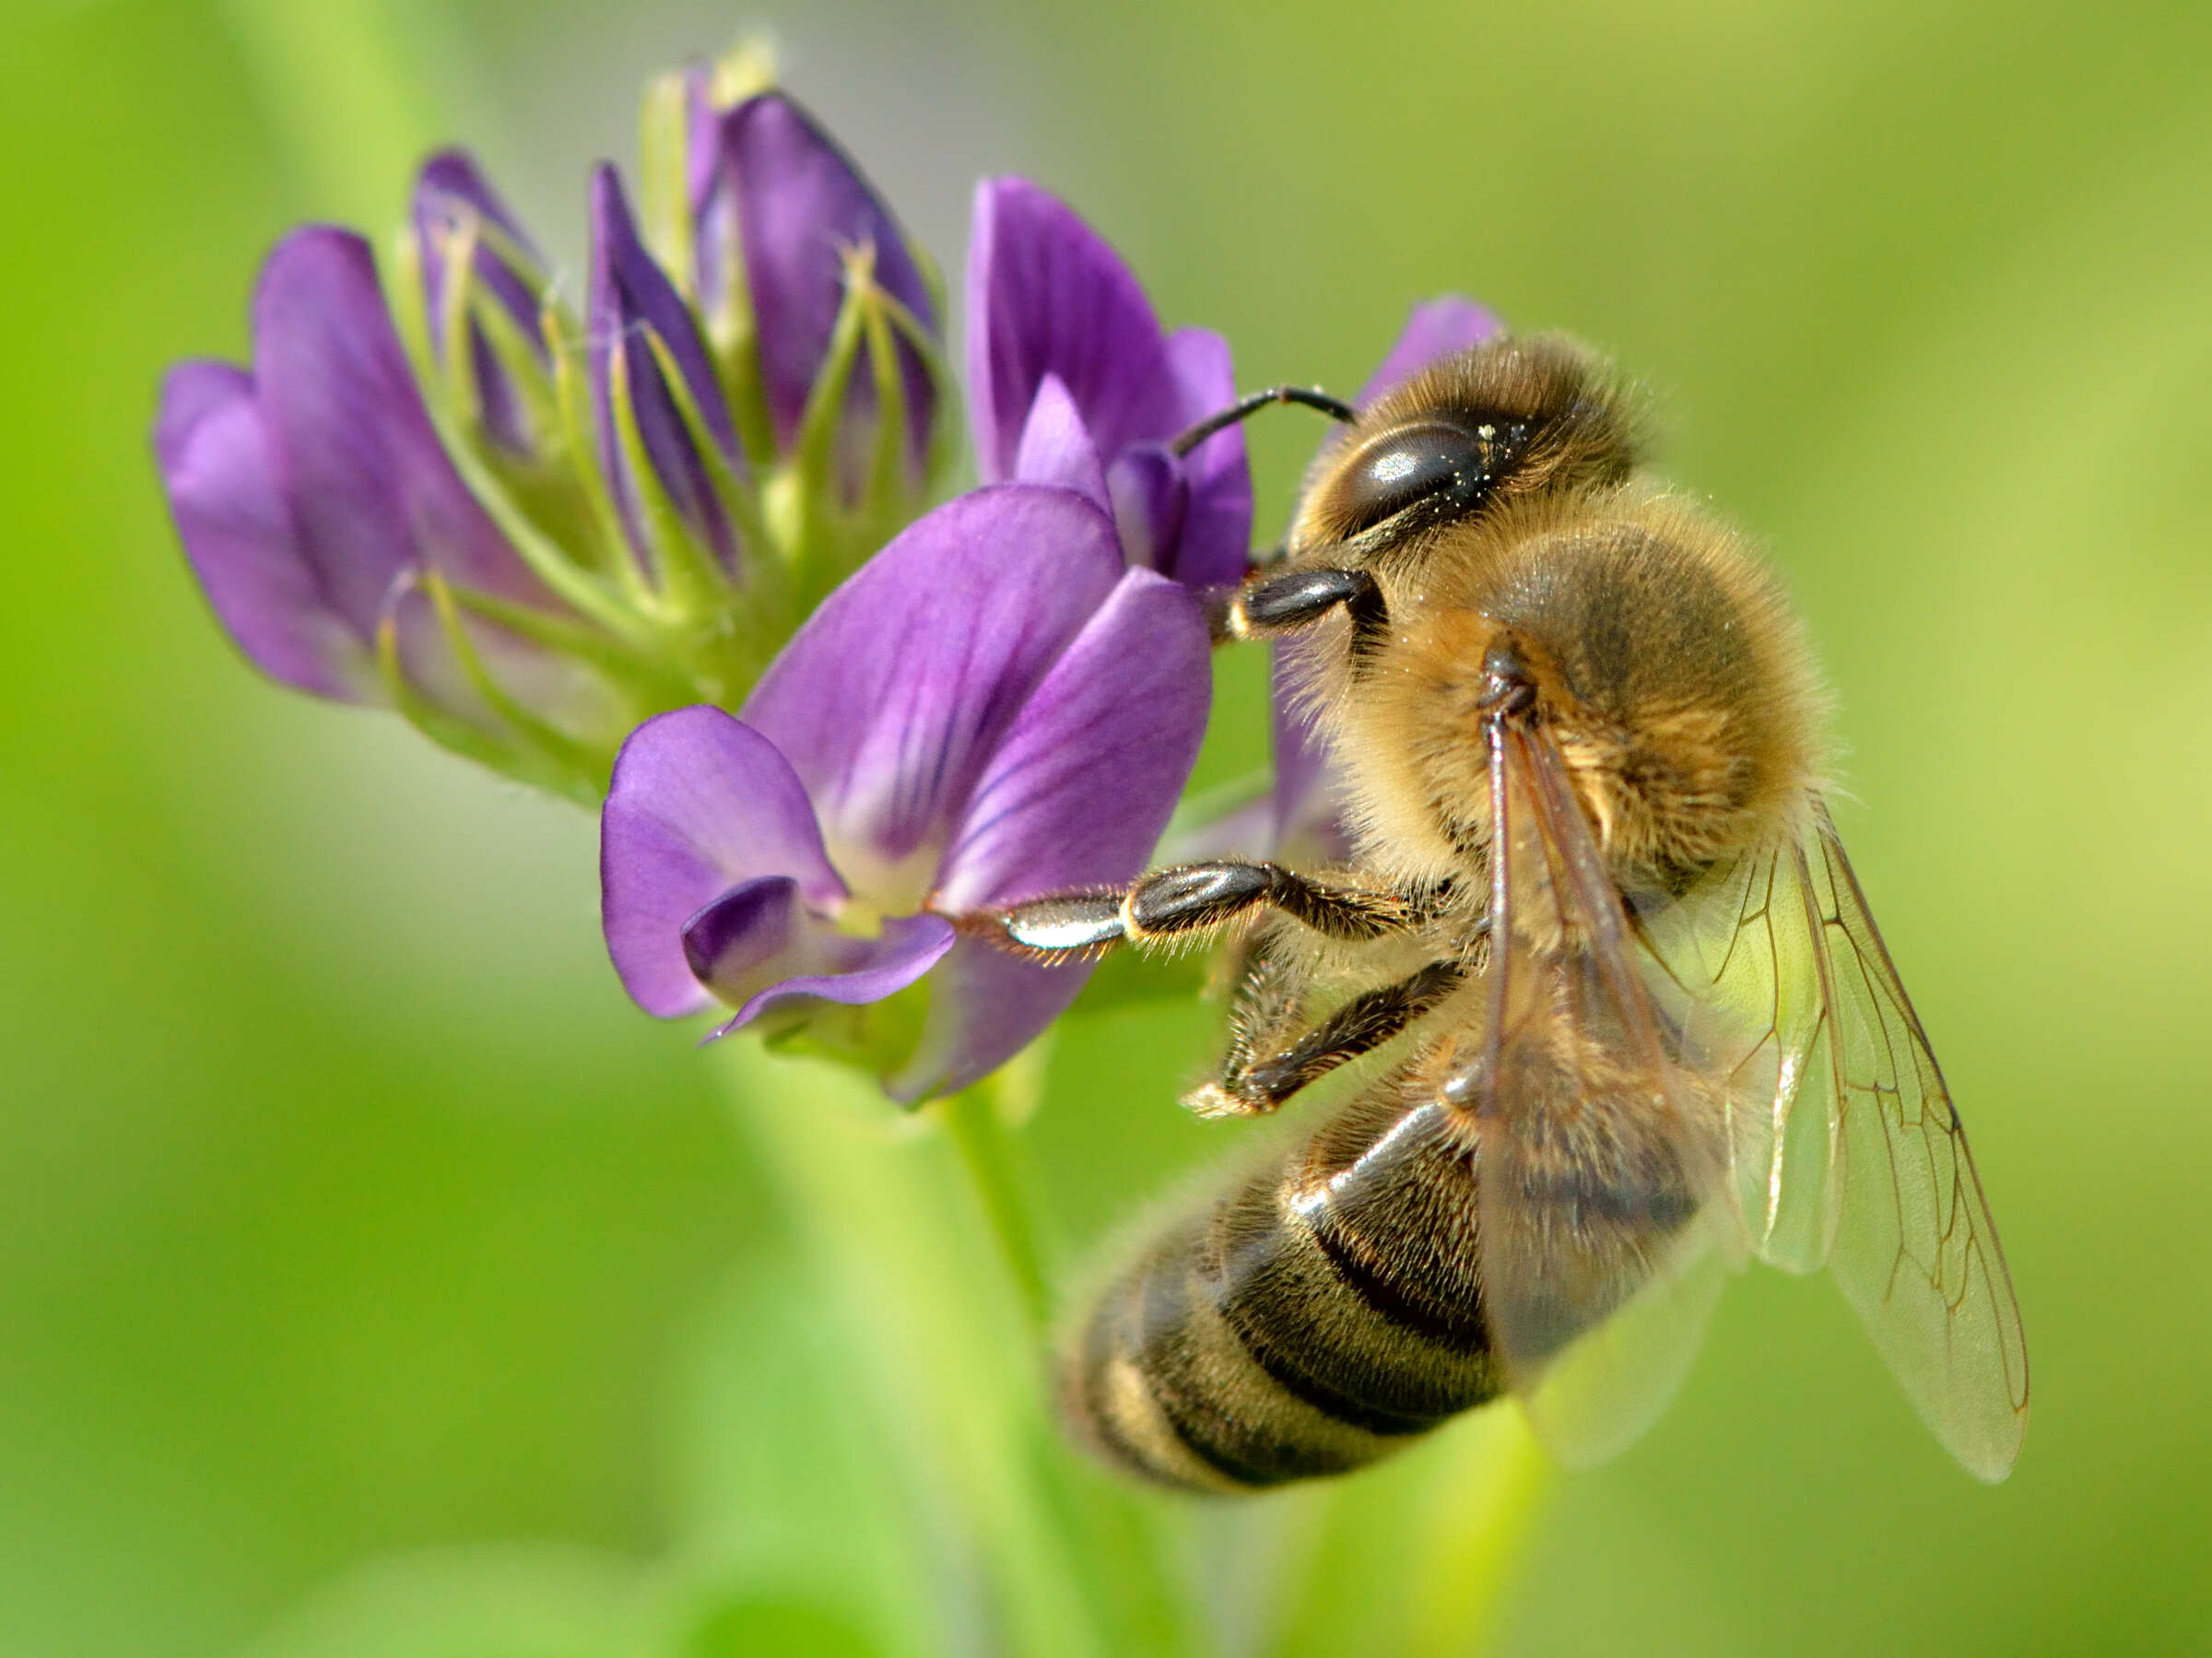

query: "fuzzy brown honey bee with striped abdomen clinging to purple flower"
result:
(984, 336), (2029, 1490)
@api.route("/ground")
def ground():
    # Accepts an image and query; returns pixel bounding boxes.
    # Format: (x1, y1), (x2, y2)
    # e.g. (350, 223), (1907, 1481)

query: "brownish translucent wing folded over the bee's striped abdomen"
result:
(1442, 723), (1735, 1464)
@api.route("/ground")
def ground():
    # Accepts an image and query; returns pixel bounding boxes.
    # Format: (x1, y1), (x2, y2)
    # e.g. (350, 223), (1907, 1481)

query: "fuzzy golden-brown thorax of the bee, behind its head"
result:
(1300, 487), (1823, 891)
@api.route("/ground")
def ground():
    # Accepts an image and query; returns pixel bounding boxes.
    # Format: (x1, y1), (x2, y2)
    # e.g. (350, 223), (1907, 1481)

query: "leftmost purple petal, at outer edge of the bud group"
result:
(153, 362), (382, 703)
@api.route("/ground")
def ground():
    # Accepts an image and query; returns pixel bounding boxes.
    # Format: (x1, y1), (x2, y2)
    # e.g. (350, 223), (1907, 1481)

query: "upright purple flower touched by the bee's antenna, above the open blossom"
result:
(967, 179), (1252, 586)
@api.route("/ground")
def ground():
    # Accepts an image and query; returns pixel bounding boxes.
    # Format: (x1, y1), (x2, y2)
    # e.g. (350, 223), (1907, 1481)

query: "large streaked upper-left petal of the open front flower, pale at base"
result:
(746, 484), (1122, 888)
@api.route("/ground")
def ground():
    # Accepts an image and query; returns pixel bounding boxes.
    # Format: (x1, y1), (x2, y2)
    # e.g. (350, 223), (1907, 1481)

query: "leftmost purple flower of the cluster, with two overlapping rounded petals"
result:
(155, 228), (583, 719)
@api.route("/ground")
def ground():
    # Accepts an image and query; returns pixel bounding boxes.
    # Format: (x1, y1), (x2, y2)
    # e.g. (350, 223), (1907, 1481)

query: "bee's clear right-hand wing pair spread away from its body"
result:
(1639, 803), (2029, 1479)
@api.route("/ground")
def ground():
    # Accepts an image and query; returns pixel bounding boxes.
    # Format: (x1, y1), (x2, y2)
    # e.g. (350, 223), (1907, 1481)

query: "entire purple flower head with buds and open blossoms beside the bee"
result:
(155, 41), (1495, 1099)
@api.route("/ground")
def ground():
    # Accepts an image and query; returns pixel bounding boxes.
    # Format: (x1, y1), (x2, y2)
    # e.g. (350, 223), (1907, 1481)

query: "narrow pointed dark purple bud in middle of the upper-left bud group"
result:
(586, 164), (743, 570)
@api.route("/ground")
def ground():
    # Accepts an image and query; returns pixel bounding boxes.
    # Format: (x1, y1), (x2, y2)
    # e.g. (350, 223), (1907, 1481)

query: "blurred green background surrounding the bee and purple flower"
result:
(0, 0), (2212, 1658)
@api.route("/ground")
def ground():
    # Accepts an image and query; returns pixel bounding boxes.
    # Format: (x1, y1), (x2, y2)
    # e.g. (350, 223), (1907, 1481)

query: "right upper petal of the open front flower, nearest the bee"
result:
(934, 570), (1212, 915)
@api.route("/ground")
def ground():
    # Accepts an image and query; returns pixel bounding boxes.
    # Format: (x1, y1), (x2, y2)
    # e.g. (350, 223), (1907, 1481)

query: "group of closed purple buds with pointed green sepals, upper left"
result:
(155, 52), (951, 800)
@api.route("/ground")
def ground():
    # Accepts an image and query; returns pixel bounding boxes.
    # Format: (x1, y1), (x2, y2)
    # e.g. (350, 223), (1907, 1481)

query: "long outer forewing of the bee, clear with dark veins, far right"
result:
(1783, 803), (2029, 1479)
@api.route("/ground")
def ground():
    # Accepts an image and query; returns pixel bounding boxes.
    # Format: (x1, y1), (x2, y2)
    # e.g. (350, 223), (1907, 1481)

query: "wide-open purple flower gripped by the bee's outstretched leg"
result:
(602, 484), (1207, 1101)
